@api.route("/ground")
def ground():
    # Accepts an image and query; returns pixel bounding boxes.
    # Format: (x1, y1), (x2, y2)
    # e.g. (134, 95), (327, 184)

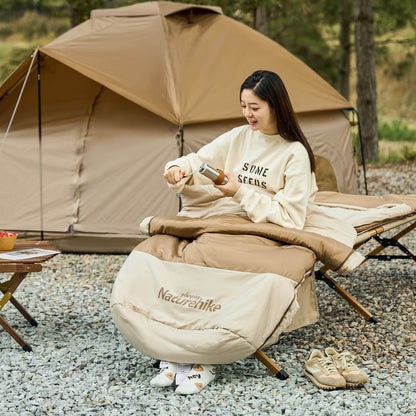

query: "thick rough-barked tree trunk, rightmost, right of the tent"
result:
(354, 0), (379, 162)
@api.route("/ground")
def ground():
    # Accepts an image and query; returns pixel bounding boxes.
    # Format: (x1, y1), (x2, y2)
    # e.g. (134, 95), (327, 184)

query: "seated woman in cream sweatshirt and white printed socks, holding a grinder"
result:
(151, 71), (317, 394)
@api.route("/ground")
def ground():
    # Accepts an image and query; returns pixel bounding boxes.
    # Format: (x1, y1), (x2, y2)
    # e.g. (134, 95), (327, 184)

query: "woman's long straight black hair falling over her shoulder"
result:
(240, 71), (315, 172)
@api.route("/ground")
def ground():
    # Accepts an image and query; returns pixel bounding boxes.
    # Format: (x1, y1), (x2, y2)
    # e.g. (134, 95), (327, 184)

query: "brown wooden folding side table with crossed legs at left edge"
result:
(0, 241), (60, 351)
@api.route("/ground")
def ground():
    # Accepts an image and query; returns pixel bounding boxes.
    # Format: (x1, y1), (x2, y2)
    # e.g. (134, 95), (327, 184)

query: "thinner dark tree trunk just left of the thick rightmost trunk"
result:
(338, 0), (352, 100)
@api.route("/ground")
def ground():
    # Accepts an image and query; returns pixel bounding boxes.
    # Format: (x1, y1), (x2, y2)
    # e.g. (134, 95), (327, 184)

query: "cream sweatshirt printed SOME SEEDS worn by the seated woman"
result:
(165, 125), (317, 229)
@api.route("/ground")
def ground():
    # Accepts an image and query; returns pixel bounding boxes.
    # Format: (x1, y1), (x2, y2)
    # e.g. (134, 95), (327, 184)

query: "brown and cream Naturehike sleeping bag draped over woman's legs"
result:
(111, 215), (360, 364)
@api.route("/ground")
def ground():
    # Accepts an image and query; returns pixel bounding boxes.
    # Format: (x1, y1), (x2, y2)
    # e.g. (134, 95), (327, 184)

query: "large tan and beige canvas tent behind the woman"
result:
(0, 1), (356, 251)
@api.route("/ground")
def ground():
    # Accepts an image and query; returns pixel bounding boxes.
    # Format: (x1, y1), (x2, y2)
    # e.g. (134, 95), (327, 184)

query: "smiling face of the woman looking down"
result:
(240, 89), (277, 134)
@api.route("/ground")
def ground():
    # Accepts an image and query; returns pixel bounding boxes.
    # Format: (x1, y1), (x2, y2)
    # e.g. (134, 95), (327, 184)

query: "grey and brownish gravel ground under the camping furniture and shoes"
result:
(0, 163), (416, 416)
